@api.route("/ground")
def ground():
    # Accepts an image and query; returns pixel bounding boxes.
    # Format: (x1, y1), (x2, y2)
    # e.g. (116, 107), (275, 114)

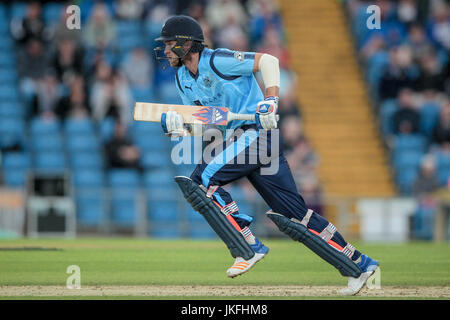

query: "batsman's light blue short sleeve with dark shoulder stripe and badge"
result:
(210, 49), (255, 80)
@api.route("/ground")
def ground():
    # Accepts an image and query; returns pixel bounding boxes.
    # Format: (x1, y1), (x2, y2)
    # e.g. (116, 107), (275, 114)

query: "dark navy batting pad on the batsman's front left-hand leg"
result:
(175, 176), (255, 260)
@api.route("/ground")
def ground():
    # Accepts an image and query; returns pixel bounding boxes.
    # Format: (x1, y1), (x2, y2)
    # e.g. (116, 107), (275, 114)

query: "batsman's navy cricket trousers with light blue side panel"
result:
(191, 125), (360, 260)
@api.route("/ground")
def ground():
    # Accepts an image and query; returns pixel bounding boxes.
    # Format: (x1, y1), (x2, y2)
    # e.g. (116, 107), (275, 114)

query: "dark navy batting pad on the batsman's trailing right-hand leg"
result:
(267, 211), (361, 278)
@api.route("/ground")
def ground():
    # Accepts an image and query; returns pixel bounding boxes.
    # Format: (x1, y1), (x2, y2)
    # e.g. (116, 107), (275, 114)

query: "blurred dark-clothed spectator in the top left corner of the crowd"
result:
(11, 1), (48, 47)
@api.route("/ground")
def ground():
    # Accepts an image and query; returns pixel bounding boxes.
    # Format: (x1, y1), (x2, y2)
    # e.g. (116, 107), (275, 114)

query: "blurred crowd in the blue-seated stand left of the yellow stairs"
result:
(0, 0), (321, 213)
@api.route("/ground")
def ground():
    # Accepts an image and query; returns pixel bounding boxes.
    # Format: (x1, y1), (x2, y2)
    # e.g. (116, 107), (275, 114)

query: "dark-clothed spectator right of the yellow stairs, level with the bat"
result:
(392, 88), (420, 134)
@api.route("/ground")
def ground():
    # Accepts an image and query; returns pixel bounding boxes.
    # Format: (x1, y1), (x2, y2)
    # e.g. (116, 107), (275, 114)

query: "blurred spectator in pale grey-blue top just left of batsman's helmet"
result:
(121, 47), (154, 88)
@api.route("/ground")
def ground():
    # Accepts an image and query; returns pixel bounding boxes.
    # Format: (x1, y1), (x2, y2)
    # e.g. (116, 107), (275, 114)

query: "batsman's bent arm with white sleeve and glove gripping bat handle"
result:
(253, 52), (280, 130)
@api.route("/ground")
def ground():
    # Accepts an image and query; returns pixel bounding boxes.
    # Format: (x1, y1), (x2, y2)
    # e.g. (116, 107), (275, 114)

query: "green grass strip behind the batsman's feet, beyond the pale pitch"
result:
(0, 238), (450, 298)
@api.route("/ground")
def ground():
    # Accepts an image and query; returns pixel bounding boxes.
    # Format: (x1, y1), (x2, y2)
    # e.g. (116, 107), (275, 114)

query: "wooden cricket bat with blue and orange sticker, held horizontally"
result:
(133, 102), (255, 126)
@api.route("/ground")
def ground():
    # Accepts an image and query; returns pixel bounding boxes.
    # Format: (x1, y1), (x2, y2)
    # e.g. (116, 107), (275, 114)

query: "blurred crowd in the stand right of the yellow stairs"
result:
(346, 0), (450, 196)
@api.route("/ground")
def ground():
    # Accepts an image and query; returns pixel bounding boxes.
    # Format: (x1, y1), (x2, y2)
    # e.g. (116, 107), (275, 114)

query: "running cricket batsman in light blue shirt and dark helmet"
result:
(155, 15), (379, 295)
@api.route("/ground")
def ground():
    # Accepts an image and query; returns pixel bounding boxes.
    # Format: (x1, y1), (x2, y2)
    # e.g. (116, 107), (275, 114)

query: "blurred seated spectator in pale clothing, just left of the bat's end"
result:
(89, 60), (132, 126)
